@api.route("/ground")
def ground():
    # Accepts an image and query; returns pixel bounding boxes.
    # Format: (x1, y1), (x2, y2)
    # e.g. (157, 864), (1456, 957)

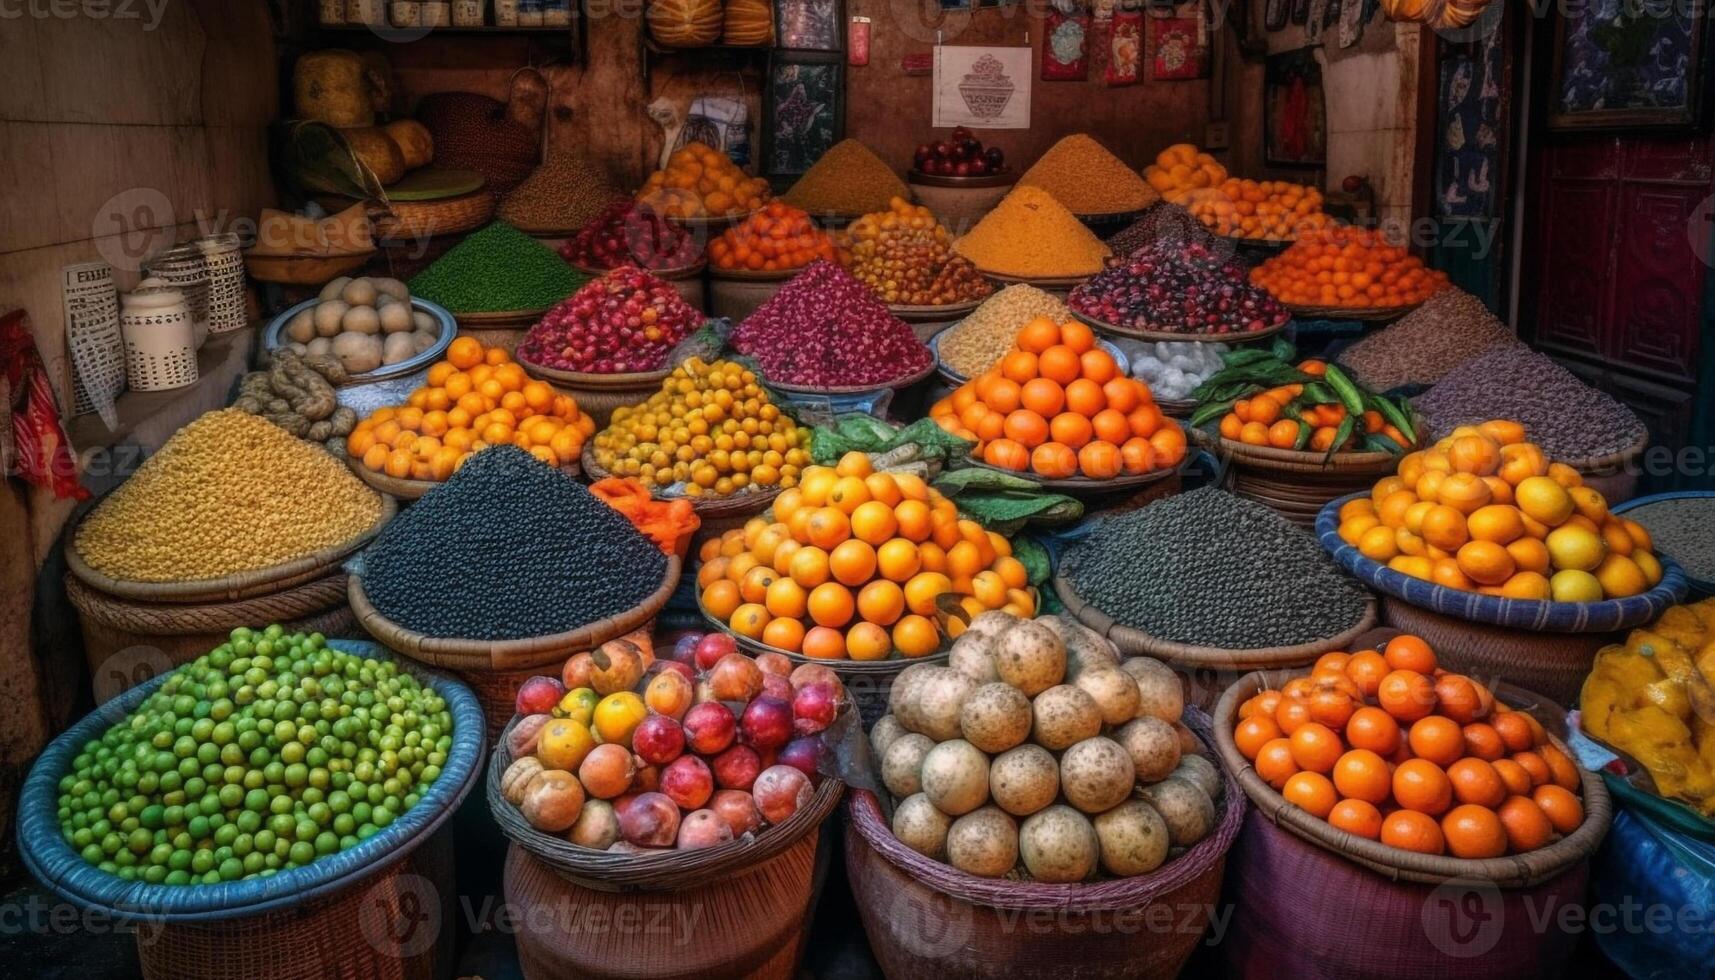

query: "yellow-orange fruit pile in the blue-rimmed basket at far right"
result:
(1339, 420), (1662, 602)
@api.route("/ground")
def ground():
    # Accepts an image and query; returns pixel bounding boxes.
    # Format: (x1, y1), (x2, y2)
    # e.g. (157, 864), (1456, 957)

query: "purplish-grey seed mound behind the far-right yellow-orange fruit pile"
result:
(1413, 347), (1646, 460)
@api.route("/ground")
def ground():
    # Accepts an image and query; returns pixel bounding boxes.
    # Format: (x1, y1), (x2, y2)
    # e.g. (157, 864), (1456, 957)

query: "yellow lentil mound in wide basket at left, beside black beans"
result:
(74, 408), (381, 582)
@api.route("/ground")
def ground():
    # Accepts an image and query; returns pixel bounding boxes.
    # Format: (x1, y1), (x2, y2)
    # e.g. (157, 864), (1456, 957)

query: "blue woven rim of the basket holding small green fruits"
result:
(17, 640), (485, 923)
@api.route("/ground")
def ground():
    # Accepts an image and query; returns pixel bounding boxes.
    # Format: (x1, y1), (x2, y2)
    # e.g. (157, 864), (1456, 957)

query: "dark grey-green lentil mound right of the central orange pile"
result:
(1060, 487), (1365, 650)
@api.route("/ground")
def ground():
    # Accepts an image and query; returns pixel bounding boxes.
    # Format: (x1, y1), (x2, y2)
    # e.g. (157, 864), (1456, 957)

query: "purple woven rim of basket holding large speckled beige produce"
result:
(847, 705), (1245, 913)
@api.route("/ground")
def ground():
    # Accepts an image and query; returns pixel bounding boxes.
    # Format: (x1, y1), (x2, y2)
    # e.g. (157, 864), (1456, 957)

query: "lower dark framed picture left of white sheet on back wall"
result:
(763, 51), (845, 177)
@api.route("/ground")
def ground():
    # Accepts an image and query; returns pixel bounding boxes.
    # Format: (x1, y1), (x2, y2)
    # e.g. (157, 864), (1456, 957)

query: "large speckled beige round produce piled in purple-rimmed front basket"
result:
(870, 611), (1223, 884)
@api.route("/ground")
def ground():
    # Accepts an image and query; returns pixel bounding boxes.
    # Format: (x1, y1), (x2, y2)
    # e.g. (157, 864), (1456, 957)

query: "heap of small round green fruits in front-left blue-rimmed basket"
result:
(58, 625), (453, 886)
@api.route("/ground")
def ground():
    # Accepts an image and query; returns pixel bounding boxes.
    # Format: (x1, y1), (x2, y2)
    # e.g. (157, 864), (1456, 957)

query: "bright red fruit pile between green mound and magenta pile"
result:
(518, 266), (705, 374)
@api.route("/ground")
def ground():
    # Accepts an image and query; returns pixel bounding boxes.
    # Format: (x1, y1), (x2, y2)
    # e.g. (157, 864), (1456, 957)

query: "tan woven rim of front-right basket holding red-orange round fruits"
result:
(1214, 669), (1614, 887)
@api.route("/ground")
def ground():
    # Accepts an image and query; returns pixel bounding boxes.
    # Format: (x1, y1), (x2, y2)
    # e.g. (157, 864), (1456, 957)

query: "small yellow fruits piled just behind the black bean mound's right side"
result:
(595, 357), (809, 498)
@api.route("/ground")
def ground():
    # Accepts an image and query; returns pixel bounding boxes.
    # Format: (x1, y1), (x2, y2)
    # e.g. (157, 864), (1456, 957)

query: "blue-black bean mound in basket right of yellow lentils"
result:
(364, 446), (667, 640)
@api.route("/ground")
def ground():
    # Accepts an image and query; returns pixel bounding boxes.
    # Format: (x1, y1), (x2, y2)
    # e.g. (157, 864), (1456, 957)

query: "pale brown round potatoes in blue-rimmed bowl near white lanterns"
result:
(280, 276), (441, 374)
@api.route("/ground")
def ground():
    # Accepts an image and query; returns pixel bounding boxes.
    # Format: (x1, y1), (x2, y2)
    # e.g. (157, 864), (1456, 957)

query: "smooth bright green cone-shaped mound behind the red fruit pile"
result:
(410, 221), (587, 312)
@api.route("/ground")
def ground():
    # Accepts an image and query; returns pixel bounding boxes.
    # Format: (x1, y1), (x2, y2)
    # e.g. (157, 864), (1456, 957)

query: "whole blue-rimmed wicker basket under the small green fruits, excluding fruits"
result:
(17, 642), (484, 980)
